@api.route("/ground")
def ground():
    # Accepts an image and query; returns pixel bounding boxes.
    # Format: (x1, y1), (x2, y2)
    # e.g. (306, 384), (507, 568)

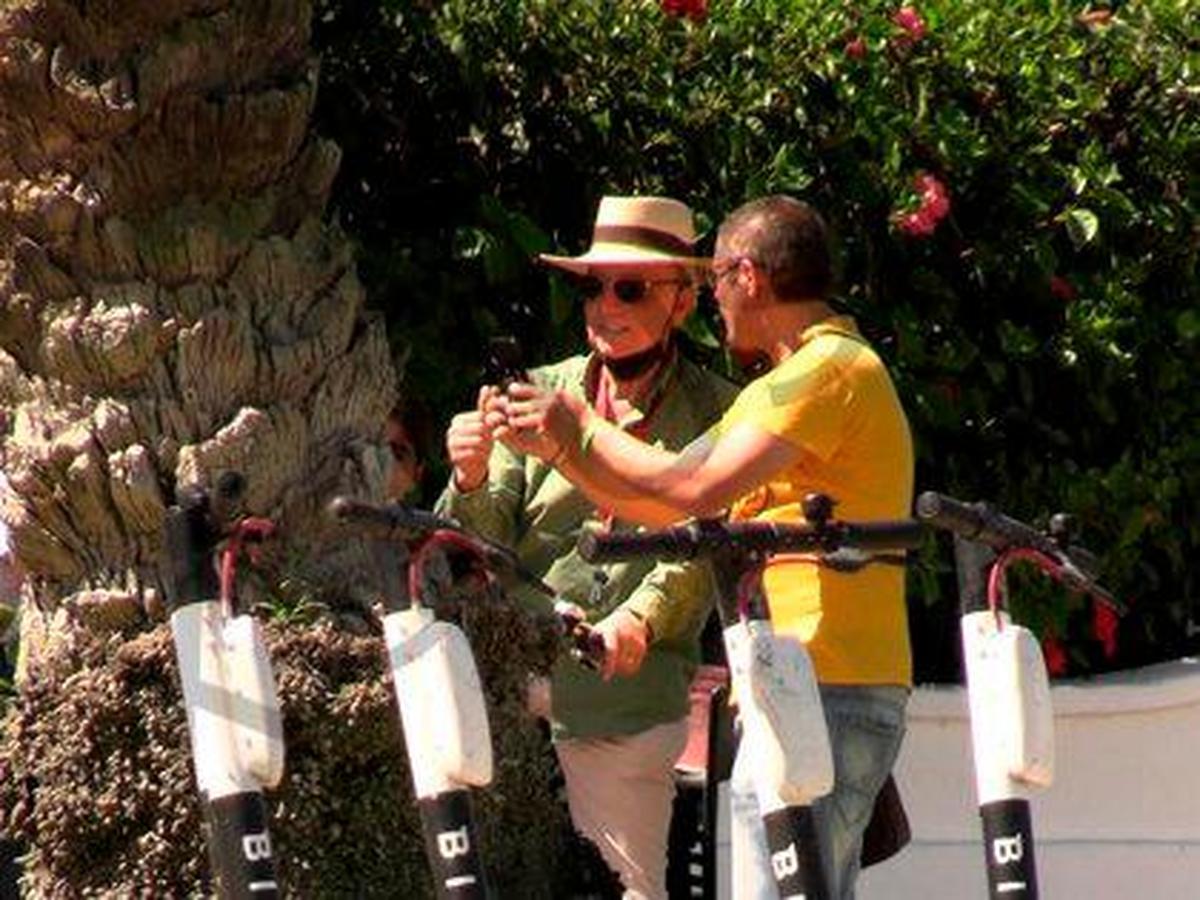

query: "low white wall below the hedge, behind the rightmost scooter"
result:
(858, 660), (1200, 900)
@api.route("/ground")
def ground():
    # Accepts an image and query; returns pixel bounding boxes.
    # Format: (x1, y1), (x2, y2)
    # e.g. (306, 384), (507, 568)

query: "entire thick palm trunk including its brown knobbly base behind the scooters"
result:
(0, 0), (585, 898)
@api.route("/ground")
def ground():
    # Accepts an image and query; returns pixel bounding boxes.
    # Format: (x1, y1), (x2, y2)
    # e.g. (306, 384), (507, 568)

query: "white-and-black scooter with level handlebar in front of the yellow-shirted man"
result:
(580, 494), (925, 900)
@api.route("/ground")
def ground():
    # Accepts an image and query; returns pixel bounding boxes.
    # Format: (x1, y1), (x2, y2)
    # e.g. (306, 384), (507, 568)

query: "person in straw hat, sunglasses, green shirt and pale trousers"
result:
(438, 197), (736, 900)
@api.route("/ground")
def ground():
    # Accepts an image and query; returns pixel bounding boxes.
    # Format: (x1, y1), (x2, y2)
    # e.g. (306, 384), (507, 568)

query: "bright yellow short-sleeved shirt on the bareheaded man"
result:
(715, 316), (913, 685)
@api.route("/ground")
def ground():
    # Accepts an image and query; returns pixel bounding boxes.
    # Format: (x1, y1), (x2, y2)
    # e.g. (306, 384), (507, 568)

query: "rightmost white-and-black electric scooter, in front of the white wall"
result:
(917, 491), (1124, 900)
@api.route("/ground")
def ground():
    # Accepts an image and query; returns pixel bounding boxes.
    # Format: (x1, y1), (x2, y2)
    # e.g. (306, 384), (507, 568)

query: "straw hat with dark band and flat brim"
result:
(538, 197), (709, 275)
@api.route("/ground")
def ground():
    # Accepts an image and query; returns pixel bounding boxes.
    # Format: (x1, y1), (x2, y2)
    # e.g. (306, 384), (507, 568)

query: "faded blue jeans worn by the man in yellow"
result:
(730, 684), (908, 900)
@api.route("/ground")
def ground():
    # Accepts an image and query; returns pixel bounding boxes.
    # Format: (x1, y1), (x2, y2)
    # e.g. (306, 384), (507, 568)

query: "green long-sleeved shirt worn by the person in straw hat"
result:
(437, 356), (737, 739)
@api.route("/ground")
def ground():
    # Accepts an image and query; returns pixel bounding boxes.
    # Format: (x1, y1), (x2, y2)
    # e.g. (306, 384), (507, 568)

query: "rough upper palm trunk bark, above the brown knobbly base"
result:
(0, 0), (395, 661)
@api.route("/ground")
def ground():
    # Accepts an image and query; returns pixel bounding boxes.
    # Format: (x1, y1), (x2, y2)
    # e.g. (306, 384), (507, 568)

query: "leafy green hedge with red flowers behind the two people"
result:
(316, 0), (1200, 678)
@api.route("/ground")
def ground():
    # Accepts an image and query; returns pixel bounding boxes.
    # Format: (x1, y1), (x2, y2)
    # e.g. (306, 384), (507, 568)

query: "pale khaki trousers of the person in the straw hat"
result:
(554, 719), (688, 900)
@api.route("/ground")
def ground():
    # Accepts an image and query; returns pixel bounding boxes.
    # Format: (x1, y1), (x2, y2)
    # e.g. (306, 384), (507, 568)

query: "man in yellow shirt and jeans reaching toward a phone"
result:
(490, 196), (913, 900)
